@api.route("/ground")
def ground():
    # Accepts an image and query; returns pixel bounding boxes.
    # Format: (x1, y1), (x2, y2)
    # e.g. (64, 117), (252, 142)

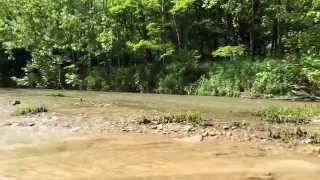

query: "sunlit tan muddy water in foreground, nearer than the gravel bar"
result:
(0, 135), (320, 180)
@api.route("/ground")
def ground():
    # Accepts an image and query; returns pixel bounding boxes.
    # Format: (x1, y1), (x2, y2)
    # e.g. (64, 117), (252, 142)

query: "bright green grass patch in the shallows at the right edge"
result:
(255, 106), (320, 124)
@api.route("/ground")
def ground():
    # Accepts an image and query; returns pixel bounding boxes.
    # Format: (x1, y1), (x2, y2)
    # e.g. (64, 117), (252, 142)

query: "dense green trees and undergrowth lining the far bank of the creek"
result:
(0, 0), (320, 96)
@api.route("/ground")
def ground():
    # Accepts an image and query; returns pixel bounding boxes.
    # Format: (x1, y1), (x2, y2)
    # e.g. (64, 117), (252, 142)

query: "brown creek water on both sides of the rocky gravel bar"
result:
(0, 89), (320, 180)
